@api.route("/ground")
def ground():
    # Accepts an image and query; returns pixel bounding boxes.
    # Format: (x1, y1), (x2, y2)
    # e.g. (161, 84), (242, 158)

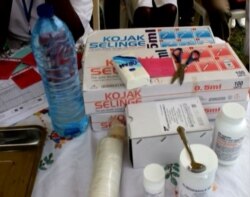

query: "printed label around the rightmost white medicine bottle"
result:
(214, 131), (244, 161)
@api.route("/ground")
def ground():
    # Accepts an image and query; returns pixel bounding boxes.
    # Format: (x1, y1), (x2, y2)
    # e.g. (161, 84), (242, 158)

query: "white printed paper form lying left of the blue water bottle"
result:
(0, 76), (48, 126)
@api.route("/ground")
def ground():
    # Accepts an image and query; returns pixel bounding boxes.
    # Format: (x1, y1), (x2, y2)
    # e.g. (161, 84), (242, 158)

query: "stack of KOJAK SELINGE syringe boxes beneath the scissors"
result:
(83, 26), (249, 131)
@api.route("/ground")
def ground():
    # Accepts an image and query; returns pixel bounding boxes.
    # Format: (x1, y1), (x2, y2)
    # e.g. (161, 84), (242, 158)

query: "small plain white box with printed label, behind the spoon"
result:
(125, 97), (213, 168)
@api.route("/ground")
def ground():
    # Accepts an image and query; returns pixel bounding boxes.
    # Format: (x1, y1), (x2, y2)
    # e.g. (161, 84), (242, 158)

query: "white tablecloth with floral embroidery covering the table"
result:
(27, 101), (250, 197)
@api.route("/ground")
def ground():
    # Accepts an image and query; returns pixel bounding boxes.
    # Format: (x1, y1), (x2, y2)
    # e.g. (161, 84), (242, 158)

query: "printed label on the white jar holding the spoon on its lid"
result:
(179, 183), (212, 197)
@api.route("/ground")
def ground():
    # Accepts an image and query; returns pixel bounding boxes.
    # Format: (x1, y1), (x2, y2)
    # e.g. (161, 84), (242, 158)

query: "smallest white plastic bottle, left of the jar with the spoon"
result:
(143, 163), (165, 197)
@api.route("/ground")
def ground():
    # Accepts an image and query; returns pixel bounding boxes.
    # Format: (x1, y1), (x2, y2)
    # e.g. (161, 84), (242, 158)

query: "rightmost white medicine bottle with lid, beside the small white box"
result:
(213, 103), (247, 165)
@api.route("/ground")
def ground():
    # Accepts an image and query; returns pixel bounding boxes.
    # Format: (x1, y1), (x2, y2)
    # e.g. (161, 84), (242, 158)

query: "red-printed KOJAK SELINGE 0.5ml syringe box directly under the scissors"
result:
(83, 39), (249, 114)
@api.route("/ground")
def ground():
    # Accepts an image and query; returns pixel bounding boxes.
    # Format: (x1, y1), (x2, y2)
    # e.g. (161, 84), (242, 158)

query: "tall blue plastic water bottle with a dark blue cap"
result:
(31, 3), (88, 138)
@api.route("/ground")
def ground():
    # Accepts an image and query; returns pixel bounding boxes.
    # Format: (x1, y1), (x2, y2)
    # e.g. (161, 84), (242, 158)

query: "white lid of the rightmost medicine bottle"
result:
(221, 103), (246, 122)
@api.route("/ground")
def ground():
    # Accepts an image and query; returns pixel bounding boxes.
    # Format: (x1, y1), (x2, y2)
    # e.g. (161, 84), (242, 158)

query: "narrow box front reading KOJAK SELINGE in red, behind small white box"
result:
(84, 87), (248, 114)
